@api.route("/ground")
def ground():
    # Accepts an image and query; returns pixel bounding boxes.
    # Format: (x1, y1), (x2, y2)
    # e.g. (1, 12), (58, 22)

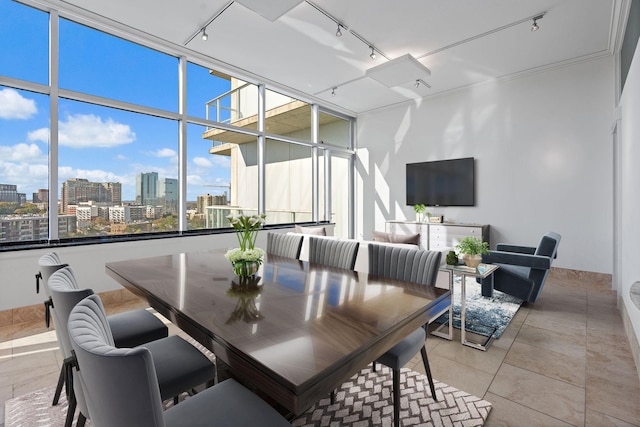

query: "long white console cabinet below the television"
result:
(386, 221), (489, 252)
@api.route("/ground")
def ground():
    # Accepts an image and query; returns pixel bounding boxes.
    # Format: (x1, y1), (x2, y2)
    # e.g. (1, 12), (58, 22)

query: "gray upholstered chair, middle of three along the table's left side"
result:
(47, 266), (215, 426)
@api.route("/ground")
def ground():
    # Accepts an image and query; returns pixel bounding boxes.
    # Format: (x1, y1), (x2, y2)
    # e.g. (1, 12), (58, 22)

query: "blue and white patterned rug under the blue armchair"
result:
(436, 277), (523, 339)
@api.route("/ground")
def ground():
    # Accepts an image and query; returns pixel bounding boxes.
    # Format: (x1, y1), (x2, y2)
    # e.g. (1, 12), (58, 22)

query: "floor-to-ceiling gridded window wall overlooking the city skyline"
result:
(0, 0), (353, 245)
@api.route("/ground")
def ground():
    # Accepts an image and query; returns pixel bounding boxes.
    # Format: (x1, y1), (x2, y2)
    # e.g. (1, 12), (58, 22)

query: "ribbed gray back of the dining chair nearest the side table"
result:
(369, 244), (442, 286)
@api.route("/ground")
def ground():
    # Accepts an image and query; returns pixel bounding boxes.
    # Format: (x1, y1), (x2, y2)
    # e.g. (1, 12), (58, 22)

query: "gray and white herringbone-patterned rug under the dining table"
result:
(4, 367), (491, 427)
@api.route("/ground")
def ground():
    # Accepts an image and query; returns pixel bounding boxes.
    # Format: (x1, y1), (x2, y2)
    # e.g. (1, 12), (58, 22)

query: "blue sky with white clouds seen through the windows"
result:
(0, 0), (230, 201)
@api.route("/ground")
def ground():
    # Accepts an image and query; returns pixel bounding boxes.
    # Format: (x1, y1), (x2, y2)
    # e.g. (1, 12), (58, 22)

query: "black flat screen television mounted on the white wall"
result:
(407, 157), (475, 206)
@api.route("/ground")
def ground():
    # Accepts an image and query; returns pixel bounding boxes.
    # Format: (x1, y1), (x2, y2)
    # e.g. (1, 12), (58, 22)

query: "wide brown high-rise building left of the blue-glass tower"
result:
(62, 178), (122, 213)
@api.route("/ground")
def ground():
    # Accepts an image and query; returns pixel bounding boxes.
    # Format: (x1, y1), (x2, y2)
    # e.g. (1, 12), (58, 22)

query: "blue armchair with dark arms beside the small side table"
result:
(480, 232), (560, 302)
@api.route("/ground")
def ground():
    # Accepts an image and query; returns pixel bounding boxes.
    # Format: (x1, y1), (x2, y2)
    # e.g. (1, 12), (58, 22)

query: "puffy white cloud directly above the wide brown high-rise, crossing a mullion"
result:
(28, 114), (136, 148)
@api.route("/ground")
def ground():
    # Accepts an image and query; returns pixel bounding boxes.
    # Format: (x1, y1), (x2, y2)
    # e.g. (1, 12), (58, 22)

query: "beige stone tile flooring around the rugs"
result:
(0, 277), (640, 427)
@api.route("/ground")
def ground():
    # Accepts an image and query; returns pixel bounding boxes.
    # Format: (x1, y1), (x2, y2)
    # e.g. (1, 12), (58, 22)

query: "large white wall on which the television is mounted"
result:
(356, 56), (615, 273)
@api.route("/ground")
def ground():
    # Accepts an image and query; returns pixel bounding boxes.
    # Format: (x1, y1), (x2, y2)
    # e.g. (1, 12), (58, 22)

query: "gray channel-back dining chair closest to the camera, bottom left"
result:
(68, 295), (290, 427)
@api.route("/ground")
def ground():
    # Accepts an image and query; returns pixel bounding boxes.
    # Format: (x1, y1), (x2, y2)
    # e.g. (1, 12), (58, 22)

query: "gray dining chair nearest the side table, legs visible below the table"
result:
(369, 244), (442, 426)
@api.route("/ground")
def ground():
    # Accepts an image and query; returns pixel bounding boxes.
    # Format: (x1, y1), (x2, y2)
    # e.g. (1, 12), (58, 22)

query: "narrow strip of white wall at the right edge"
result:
(616, 40), (640, 352)
